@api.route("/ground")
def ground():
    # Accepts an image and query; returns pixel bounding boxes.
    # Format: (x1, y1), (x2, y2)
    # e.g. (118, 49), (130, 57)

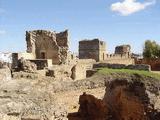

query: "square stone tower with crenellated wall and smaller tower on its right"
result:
(79, 39), (135, 65)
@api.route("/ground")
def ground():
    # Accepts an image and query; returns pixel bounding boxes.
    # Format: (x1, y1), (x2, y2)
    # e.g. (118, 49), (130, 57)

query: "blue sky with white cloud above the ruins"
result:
(0, 0), (160, 53)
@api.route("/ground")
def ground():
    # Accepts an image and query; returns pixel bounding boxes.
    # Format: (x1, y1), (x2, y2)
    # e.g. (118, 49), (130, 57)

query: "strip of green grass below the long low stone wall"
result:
(98, 68), (160, 80)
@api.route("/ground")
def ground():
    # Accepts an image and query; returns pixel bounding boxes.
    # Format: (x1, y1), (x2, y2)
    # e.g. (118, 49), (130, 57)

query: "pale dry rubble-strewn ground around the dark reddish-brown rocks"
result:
(0, 67), (160, 120)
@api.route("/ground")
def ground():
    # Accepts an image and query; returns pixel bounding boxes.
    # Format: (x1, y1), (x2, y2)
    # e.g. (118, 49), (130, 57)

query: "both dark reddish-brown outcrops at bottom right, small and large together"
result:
(72, 75), (160, 120)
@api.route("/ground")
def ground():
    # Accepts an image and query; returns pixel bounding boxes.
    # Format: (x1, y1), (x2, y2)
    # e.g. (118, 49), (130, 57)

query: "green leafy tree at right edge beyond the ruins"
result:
(143, 40), (160, 59)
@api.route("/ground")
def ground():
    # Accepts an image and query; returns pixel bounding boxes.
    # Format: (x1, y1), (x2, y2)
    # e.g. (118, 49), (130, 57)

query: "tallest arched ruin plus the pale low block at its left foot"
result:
(12, 30), (70, 69)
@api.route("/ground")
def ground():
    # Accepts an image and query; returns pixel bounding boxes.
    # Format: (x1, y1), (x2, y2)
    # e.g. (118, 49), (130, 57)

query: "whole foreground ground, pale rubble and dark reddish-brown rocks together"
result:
(0, 68), (160, 120)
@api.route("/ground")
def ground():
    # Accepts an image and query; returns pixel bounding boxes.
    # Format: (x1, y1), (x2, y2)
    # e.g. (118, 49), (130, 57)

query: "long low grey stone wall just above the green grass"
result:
(93, 63), (151, 71)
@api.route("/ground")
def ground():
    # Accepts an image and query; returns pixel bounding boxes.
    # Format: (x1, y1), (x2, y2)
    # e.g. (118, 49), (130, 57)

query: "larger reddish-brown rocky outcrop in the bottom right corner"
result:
(104, 79), (160, 120)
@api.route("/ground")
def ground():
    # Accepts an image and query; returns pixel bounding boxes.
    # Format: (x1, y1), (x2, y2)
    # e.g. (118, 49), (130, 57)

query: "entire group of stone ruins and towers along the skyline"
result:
(12, 30), (149, 80)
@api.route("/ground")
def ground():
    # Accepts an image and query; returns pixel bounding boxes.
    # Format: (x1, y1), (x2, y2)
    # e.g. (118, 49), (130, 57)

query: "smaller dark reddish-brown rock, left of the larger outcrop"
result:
(78, 93), (108, 120)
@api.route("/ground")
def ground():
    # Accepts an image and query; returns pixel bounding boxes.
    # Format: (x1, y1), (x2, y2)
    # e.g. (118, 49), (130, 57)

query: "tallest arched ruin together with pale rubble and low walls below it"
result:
(12, 30), (95, 80)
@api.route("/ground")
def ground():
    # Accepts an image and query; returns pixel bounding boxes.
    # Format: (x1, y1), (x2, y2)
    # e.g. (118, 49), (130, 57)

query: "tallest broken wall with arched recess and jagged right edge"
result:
(26, 30), (68, 64)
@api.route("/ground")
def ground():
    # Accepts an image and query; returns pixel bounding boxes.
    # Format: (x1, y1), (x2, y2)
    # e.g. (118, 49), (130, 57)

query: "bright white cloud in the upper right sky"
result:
(111, 0), (156, 16)
